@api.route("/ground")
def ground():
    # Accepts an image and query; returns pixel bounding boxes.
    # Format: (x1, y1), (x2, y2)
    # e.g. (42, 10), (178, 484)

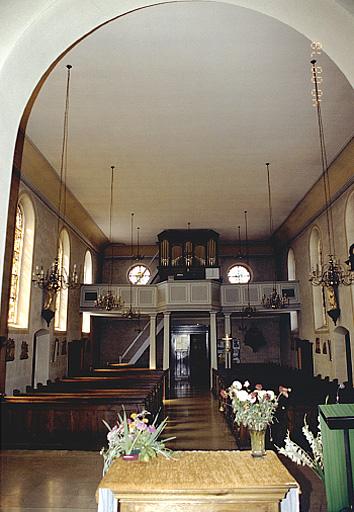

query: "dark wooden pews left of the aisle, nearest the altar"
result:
(0, 371), (165, 450)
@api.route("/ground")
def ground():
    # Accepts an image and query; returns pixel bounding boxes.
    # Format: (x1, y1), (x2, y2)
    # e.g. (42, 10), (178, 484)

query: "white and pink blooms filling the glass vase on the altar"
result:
(221, 380), (291, 431)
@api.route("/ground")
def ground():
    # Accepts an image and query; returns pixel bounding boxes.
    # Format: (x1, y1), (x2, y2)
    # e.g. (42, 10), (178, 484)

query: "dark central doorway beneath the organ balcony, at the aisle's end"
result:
(171, 325), (210, 390)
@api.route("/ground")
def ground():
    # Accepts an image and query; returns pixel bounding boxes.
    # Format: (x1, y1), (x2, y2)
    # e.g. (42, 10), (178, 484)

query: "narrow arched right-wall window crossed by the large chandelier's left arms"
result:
(310, 227), (327, 329)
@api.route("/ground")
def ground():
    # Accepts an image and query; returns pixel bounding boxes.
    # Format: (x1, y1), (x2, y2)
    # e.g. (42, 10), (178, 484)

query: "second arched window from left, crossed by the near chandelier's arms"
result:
(54, 229), (70, 331)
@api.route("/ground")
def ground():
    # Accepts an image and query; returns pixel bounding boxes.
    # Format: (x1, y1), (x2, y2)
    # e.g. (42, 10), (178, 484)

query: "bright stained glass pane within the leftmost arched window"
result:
(8, 205), (25, 324)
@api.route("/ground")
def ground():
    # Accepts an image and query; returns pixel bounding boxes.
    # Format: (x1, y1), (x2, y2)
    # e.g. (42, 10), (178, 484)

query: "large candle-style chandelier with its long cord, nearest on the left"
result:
(32, 64), (80, 292)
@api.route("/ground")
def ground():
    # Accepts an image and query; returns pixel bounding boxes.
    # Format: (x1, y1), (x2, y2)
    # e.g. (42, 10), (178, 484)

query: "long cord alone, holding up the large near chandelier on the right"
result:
(311, 59), (336, 255)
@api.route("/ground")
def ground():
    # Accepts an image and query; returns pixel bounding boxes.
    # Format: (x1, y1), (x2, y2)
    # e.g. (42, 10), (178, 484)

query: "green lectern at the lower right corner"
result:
(320, 404), (354, 512)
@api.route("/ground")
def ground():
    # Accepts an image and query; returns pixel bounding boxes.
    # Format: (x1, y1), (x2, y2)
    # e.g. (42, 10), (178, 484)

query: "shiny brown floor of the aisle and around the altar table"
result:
(0, 389), (326, 512)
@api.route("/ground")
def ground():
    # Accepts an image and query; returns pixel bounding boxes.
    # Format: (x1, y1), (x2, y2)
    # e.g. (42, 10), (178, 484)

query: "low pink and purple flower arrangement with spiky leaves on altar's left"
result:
(100, 409), (175, 474)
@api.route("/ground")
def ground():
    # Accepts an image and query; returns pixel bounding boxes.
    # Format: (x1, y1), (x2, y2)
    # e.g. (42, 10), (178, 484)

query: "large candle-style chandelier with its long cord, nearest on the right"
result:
(309, 58), (354, 288)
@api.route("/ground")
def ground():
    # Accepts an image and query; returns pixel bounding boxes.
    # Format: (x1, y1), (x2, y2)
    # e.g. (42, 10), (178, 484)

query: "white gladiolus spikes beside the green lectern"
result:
(276, 416), (324, 481)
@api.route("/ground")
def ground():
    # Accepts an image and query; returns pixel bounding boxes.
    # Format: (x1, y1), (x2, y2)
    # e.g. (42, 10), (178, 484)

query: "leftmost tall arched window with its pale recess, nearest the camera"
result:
(8, 194), (35, 329)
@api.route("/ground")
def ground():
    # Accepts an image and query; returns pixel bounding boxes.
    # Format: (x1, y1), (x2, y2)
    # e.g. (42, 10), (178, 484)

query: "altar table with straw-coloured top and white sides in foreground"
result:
(96, 451), (299, 512)
